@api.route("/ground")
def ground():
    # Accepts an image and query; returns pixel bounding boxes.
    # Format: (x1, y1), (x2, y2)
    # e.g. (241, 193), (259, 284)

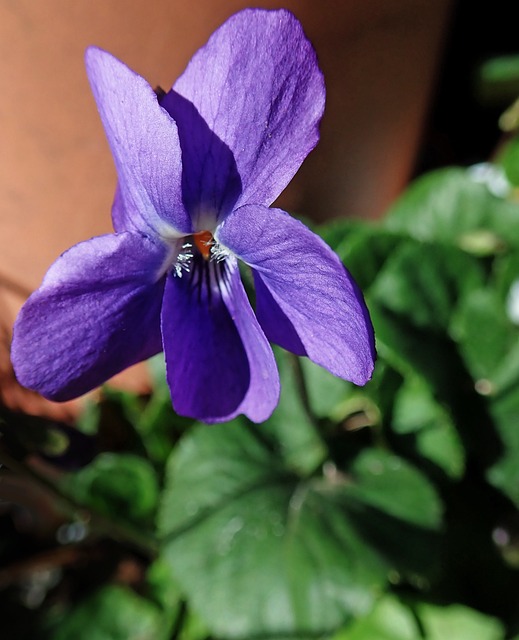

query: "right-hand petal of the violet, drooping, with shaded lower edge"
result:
(217, 206), (375, 385)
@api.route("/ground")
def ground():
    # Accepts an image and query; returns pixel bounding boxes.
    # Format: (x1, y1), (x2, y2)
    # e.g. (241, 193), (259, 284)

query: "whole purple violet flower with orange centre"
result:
(12, 9), (375, 422)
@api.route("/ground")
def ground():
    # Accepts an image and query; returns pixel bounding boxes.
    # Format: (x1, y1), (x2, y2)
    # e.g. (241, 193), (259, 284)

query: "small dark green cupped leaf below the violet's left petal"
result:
(62, 453), (159, 522)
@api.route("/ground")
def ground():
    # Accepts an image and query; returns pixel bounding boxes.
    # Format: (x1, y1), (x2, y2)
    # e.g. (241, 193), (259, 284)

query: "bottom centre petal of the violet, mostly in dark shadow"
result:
(162, 258), (279, 423)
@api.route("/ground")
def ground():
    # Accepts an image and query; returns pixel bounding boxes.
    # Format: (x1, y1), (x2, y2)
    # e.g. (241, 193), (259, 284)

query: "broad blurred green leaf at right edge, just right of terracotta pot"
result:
(385, 168), (519, 254)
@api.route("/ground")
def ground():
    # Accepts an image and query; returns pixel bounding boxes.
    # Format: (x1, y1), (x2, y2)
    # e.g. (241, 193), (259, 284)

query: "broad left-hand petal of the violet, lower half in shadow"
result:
(11, 232), (167, 401)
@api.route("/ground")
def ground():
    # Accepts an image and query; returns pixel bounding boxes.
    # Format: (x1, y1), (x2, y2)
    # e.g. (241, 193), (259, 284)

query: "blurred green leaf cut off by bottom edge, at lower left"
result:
(50, 586), (167, 640)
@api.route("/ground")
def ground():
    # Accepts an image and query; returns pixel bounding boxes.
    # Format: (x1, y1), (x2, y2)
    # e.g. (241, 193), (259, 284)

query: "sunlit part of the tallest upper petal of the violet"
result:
(162, 9), (325, 211)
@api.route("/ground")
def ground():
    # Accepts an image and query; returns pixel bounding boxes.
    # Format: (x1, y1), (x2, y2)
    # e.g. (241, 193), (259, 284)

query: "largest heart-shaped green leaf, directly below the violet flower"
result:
(159, 422), (439, 639)
